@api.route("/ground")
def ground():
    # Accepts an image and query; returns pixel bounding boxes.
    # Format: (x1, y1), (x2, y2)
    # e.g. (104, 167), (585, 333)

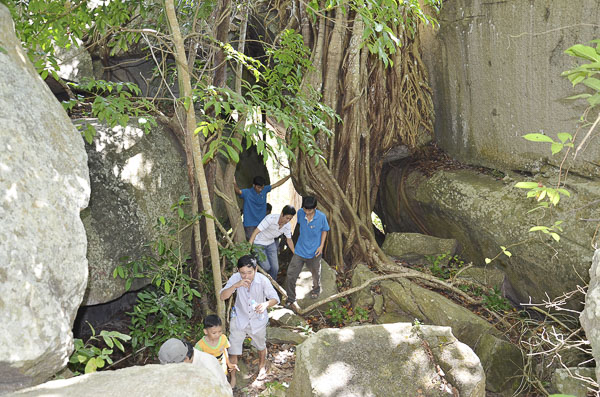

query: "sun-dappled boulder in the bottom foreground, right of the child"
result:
(287, 323), (485, 397)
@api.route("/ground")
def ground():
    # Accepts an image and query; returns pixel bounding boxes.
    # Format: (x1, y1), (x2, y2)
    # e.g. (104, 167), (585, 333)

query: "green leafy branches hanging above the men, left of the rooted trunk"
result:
(194, 30), (340, 163)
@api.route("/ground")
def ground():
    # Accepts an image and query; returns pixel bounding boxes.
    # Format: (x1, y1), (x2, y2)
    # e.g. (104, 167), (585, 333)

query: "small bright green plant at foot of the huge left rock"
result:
(69, 323), (131, 374)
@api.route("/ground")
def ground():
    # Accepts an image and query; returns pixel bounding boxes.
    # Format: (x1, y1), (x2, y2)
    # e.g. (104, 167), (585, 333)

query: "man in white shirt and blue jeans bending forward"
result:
(248, 205), (296, 280)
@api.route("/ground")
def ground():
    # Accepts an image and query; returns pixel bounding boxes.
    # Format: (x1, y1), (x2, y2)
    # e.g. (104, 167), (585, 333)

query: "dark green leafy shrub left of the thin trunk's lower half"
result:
(113, 196), (202, 350)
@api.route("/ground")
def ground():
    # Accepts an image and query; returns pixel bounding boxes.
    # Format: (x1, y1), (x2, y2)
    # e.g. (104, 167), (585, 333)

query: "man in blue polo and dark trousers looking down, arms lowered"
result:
(285, 196), (329, 307)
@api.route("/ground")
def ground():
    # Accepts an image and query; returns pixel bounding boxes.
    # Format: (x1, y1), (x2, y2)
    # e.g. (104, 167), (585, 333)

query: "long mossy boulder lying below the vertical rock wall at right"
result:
(382, 169), (600, 308)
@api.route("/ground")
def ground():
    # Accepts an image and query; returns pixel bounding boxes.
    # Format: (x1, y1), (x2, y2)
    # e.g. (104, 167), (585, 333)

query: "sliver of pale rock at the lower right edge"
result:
(579, 249), (600, 379)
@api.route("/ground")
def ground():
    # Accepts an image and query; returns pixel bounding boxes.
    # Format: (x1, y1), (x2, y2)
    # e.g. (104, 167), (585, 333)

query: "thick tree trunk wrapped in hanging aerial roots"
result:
(292, 4), (432, 271)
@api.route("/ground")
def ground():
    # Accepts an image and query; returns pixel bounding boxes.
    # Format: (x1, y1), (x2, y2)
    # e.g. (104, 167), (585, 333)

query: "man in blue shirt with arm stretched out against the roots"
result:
(233, 175), (290, 240)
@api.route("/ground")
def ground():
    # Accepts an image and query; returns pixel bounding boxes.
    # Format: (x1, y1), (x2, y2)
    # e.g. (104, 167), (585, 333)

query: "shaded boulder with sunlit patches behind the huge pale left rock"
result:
(82, 119), (190, 305)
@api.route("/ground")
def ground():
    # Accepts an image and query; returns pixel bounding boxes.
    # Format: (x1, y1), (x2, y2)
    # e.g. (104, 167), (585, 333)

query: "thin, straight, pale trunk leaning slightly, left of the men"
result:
(165, 0), (225, 321)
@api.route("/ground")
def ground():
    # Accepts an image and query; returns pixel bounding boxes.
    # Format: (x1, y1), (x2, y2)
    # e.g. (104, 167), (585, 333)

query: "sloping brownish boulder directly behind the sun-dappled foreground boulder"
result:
(352, 265), (523, 392)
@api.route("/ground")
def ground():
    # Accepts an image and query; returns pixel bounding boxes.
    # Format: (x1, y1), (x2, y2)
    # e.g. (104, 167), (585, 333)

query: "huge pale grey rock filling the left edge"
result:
(0, 5), (90, 394)
